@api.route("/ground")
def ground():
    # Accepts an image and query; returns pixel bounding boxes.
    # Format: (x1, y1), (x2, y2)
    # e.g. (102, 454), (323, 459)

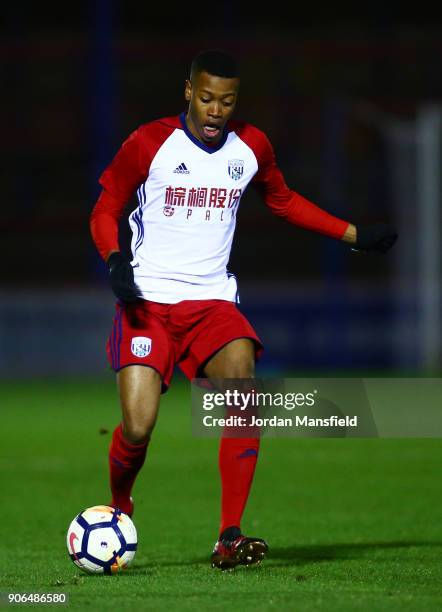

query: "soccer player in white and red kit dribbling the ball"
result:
(90, 49), (397, 569)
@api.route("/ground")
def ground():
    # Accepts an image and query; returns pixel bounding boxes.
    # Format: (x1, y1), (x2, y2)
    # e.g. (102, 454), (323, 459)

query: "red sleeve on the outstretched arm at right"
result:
(239, 124), (349, 239)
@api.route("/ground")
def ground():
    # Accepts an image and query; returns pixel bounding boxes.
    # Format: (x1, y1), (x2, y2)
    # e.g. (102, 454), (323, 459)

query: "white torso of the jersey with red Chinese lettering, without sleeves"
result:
(129, 114), (258, 303)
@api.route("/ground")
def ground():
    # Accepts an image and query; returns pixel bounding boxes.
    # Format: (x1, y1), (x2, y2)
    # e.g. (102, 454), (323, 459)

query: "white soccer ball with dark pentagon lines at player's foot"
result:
(66, 506), (137, 574)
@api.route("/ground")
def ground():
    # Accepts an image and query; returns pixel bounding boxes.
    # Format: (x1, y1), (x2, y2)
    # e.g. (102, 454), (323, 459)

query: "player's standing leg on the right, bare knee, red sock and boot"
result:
(204, 338), (267, 569)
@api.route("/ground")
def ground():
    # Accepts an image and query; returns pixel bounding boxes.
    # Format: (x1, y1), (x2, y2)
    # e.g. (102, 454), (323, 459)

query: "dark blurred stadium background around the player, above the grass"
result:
(0, 0), (442, 378)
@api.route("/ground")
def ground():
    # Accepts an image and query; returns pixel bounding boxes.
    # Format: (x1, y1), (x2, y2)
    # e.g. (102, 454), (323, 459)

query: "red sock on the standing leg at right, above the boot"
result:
(219, 437), (260, 533)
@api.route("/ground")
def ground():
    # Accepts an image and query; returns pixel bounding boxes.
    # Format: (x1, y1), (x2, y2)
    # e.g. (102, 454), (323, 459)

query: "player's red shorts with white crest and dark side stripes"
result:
(106, 300), (263, 391)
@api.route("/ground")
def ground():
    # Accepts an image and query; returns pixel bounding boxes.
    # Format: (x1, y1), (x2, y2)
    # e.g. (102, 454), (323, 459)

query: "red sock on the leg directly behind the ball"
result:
(109, 424), (147, 514)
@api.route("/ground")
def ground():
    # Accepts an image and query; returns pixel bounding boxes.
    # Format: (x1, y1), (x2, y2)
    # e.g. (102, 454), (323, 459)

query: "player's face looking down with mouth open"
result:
(184, 72), (239, 145)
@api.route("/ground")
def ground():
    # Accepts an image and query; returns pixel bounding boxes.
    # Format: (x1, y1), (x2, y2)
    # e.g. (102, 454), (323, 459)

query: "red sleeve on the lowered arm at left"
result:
(90, 118), (179, 260)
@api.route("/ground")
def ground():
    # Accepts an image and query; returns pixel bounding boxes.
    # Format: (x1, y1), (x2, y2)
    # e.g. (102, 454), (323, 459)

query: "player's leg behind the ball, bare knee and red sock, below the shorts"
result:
(109, 365), (162, 515)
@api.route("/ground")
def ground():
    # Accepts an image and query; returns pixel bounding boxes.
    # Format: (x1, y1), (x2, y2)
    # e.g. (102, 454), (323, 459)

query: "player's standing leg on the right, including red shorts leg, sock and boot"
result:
(173, 300), (267, 569)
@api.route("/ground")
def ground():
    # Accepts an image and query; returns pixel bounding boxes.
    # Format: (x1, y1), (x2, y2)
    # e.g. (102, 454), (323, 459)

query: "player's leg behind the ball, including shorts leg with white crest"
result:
(107, 300), (174, 514)
